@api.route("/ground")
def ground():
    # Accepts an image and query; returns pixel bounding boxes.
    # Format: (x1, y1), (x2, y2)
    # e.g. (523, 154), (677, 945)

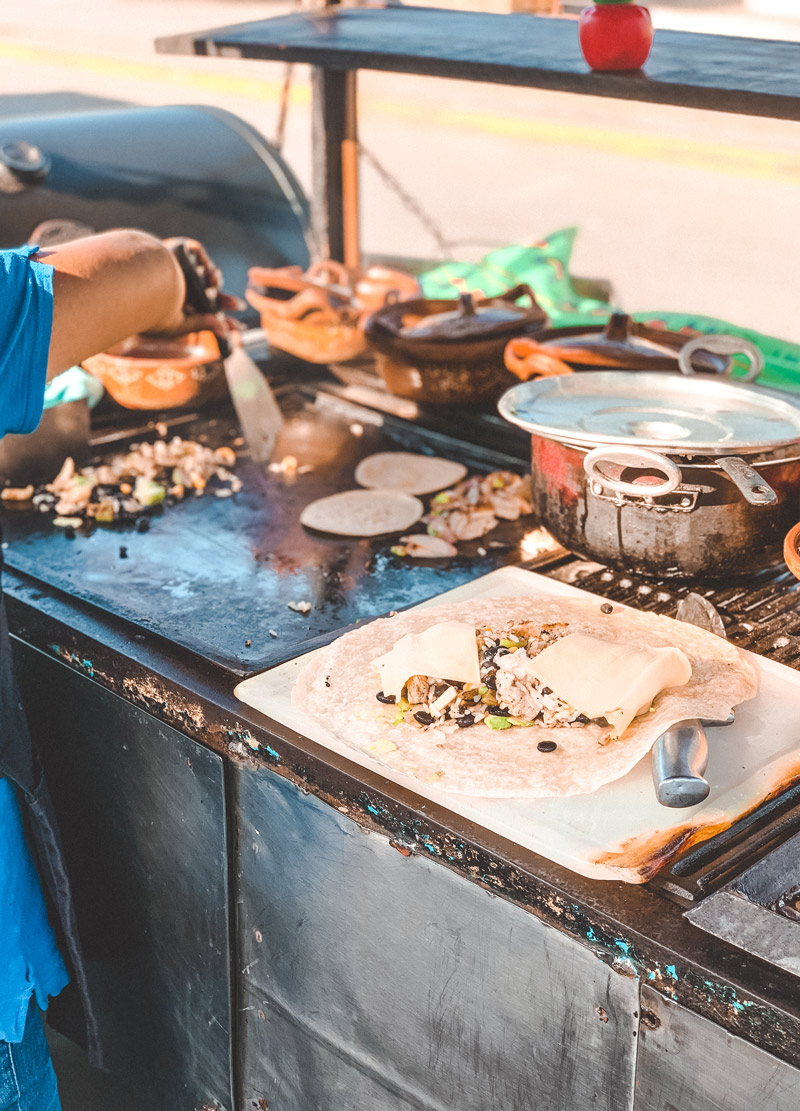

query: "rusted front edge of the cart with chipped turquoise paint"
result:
(6, 573), (800, 1067)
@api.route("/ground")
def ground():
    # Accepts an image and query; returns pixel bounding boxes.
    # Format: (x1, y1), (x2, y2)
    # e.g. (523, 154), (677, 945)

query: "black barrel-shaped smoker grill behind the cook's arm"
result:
(0, 107), (309, 302)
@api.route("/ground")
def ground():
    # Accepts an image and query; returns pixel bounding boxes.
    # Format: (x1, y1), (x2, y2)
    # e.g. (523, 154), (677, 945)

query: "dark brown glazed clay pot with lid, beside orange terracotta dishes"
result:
(364, 286), (547, 404)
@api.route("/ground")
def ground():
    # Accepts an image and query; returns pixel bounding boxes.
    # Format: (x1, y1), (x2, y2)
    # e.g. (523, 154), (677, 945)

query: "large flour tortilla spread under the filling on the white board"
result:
(292, 598), (758, 799)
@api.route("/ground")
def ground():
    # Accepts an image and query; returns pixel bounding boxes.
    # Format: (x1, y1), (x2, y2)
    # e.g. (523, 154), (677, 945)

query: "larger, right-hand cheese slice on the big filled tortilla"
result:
(526, 632), (692, 737)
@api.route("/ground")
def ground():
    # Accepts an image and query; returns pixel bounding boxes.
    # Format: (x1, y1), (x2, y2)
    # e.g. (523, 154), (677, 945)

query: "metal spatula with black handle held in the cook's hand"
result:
(173, 243), (283, 463)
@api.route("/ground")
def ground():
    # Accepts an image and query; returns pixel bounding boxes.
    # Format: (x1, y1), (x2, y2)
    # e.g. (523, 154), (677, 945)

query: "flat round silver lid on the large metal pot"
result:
(499, 370), (800, 456)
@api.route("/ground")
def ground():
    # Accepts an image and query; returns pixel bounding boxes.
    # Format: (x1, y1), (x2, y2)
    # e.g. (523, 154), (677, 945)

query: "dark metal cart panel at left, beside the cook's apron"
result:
(16, 644), (232, 1111)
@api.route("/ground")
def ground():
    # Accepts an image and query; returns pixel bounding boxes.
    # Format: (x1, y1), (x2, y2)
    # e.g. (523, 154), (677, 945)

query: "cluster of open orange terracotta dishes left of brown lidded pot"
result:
(246, 261), (419, 363)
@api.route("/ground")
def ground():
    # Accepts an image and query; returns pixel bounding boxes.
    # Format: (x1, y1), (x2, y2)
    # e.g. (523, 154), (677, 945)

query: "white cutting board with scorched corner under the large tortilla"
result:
(236, 567), (800, 883)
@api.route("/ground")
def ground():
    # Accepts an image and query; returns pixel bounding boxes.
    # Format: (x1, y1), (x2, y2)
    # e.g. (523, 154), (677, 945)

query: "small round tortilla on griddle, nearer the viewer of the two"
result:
(300, 490), (424, 537)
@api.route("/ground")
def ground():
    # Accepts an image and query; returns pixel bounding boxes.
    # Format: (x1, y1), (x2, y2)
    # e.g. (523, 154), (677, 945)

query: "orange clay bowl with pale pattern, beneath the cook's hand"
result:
(83, 332), (228, 410)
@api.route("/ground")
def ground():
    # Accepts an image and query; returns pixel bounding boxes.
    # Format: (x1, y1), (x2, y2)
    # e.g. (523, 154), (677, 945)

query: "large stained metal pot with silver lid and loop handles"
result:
(500, 371), (800, 579)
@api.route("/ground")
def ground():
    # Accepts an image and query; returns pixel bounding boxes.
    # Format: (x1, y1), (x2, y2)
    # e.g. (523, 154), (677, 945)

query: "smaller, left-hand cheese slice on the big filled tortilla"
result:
(372, 621), (480, 698)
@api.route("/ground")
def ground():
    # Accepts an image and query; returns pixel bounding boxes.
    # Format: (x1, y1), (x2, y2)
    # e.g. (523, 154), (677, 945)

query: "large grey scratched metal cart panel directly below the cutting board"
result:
(233, 769), (638, 1111)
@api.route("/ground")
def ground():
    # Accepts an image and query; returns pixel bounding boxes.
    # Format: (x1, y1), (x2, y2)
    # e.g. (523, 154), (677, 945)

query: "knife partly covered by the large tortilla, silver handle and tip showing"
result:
(652, 593), (732, 808)
